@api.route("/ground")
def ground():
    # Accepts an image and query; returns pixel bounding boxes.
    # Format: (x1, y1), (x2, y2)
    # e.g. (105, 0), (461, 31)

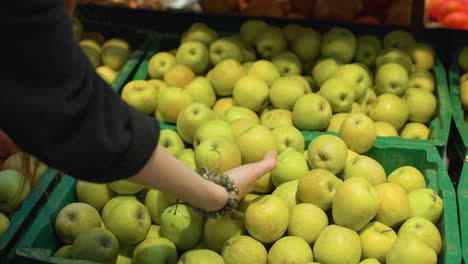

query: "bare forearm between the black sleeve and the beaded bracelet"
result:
(130, 145), (228, 211)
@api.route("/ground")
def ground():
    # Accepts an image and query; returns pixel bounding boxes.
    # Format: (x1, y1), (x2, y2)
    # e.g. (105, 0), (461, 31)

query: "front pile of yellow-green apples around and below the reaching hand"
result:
(54, 126), (443, 264)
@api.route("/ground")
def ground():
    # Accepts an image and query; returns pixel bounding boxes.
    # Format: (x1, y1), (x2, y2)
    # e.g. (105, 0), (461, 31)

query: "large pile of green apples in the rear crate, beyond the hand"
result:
(122, 20), (437, 141)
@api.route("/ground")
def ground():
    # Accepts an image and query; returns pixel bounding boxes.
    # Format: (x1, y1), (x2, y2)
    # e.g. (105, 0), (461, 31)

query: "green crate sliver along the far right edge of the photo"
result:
(449, 49), (468, 263)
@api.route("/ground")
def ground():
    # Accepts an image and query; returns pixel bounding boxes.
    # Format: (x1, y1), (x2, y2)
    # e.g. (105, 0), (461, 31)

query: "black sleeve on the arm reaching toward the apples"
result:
(0, 0), (159, 182)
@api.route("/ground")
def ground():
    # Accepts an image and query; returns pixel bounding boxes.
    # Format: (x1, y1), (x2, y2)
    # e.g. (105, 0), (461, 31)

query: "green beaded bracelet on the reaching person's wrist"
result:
(193, 167), (239, 218)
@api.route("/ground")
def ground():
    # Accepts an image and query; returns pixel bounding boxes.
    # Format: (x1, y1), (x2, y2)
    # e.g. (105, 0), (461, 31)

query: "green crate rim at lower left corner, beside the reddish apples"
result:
(0, 168), (58, 263)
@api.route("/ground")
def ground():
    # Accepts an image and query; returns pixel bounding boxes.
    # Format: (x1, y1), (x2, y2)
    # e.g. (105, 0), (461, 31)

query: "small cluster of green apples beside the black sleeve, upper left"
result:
(72, 17), (131, 84)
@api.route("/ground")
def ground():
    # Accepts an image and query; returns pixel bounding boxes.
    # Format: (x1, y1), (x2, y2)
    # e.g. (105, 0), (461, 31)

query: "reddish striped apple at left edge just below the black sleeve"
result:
(1, 152), (48, 186)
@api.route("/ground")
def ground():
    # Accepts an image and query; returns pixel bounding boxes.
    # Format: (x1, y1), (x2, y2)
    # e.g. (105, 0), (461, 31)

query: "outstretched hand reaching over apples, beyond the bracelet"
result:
(226, 152), (277, 200)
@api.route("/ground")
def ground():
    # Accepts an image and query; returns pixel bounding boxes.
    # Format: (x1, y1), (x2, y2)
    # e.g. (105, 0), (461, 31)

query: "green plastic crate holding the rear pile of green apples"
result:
(128, 33), (451, 156)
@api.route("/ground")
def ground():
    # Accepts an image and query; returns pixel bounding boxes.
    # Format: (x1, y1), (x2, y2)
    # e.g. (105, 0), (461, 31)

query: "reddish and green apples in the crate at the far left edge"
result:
(0, 130), (47, 236)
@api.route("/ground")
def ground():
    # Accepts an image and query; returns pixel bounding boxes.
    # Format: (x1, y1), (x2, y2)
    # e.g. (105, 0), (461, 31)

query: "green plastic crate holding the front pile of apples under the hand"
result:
(14, 139), (461, 264)
